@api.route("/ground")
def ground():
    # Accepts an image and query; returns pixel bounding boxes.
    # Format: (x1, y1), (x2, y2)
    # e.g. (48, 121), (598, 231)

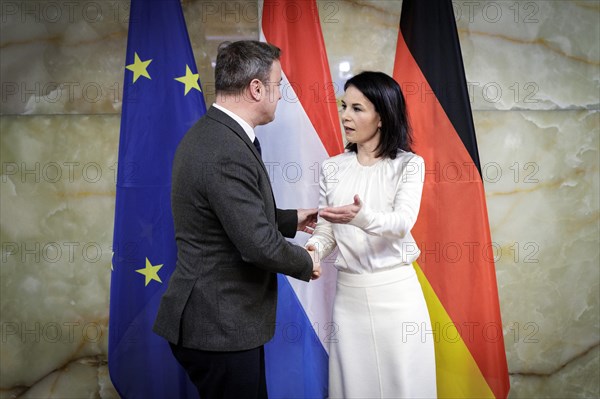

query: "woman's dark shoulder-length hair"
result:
(344, 71), (412, 159)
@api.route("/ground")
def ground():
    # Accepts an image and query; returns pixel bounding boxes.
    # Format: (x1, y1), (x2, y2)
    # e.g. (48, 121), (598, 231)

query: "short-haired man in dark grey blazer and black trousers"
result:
(154, 41), (321, 399)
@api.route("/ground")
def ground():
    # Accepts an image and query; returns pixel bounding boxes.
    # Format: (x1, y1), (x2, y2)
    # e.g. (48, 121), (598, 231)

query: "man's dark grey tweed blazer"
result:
(153, 107), (312, 351)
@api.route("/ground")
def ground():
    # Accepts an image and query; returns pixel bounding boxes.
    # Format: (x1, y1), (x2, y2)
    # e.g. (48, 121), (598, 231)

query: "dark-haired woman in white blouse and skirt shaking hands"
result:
(306, 72), (436, 398)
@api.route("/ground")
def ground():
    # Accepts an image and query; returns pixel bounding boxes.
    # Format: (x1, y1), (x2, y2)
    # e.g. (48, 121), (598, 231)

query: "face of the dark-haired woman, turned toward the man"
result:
(341, 86), (381, 149)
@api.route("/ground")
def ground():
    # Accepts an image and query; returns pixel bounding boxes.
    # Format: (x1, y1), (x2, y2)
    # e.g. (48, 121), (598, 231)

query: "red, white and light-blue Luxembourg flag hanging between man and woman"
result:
(256, 0), (343, 398)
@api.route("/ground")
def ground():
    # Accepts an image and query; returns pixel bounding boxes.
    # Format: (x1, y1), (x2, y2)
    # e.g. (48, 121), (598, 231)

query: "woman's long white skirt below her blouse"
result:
(329, 266), (437, 399)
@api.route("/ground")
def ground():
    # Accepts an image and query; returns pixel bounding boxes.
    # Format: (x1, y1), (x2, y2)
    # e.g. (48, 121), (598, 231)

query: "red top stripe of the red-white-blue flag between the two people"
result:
(262, 0), (344, 156)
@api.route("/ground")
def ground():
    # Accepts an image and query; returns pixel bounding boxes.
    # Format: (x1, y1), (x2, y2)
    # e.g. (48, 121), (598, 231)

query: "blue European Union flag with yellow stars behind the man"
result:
(108, 0), (206, 399)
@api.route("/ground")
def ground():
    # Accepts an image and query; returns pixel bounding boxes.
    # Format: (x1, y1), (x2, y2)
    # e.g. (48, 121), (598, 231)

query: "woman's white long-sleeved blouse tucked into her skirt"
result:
(306, 151), (425, 273)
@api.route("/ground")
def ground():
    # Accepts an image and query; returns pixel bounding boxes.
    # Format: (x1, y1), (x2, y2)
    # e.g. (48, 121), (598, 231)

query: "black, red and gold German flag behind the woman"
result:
(394, 0), (509, 398)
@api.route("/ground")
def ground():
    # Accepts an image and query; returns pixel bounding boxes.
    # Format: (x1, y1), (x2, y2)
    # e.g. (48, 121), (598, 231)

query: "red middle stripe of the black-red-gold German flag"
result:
(394, 14), (509, 398)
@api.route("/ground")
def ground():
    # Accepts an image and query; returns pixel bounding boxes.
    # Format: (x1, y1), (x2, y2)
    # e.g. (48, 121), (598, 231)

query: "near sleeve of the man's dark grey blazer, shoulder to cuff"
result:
(202, 149), (312, 281)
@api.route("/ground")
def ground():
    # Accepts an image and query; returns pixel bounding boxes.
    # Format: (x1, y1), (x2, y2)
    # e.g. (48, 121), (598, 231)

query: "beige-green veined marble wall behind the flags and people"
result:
(0, 0), (600, 398)
